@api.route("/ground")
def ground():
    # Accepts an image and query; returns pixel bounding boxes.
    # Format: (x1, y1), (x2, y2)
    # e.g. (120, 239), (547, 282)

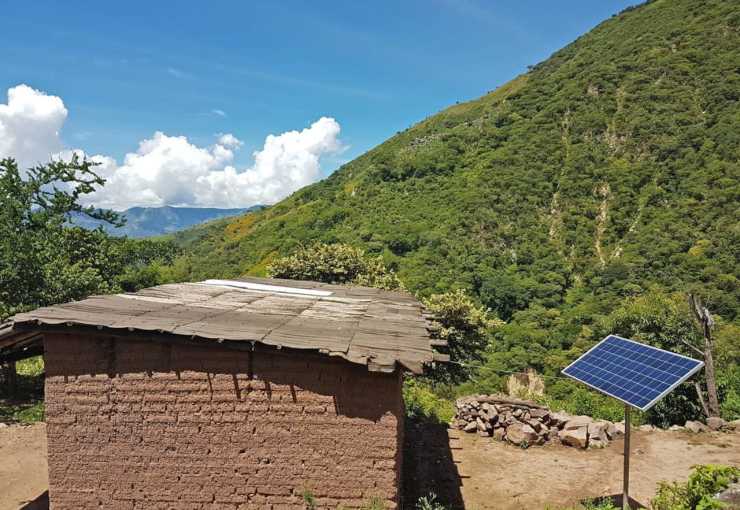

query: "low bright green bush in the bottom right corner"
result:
(650, 464), (740, 510)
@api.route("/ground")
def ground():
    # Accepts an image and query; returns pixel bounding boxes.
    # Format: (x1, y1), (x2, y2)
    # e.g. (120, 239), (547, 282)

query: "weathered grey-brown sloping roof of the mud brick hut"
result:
(0, 278), (446, 373)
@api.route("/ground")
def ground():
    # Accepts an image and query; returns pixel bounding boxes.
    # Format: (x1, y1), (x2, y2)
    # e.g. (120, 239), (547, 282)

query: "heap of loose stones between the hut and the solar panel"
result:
(452, 395), (624, 448)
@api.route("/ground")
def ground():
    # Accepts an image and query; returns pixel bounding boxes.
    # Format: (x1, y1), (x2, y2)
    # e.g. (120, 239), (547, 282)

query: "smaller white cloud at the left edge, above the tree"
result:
(0, 85), (67, 168)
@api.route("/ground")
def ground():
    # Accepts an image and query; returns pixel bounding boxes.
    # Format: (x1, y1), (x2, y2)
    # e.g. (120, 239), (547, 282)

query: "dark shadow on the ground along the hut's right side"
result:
(403, 420), (465, 510)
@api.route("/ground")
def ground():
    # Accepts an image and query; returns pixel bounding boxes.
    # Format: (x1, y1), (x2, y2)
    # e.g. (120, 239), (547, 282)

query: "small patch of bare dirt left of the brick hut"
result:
(0, 423), (49, 510)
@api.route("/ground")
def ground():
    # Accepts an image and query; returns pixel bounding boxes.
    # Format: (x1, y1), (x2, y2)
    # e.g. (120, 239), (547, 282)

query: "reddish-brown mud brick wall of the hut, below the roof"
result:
(44, 333), (403, 510)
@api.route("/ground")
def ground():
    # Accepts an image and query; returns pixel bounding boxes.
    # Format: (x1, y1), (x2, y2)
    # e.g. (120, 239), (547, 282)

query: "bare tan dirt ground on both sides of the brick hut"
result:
(0, 423), (740, 510)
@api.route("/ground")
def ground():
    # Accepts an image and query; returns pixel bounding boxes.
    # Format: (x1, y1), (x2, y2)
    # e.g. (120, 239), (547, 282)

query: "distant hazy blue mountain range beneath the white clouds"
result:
(73, 205), (264, 237)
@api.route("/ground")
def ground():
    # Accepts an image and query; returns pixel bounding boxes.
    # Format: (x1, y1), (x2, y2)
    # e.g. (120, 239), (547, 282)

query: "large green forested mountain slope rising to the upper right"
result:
(165, 0), (740, 418)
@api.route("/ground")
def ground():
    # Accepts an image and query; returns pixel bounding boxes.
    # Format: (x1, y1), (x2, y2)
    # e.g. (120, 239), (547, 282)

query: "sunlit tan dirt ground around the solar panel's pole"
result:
(452, 431), (740, 510)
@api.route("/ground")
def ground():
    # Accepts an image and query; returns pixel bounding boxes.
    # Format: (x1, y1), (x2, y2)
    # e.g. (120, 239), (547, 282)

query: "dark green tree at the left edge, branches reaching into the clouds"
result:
(0, 156), (121, 316)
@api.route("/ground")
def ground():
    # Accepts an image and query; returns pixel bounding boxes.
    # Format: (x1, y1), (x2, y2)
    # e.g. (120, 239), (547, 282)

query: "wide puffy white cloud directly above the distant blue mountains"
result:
(85, 117), (341, 209)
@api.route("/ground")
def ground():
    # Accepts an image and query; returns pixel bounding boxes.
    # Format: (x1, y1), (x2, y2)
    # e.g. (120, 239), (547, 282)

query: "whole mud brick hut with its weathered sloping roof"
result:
(0, 278), (445, 510)
